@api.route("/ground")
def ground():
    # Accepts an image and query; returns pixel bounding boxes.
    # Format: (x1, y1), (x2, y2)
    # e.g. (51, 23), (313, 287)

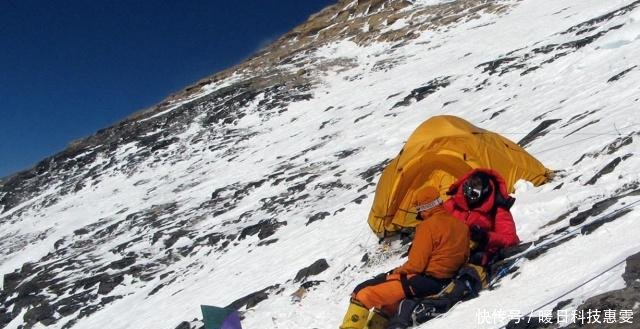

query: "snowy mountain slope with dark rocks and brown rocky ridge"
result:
(0, 0), (640, 328)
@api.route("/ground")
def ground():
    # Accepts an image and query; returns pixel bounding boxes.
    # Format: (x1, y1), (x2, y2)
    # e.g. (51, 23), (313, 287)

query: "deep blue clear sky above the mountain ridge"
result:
(0, 0), (337, 177)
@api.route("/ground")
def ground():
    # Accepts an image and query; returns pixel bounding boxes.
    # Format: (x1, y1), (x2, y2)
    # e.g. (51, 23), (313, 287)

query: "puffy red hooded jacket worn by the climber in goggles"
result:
(444, 169), (520, 254)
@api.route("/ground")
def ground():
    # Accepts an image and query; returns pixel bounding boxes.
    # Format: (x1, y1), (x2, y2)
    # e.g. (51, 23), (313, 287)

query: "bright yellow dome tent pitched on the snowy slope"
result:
(368, 115), (550, 236)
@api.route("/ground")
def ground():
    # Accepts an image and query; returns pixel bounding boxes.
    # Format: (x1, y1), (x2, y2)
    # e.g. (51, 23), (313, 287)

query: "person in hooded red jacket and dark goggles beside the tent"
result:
(444, 169), (520, 266)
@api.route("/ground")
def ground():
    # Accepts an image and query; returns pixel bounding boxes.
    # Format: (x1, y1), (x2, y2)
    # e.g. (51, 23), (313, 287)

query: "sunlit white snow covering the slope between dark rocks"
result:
(0, 0), (640, 329)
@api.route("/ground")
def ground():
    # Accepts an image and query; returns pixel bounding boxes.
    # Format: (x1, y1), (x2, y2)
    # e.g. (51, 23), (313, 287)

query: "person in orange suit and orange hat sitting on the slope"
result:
(340, 186), (469, 329)
